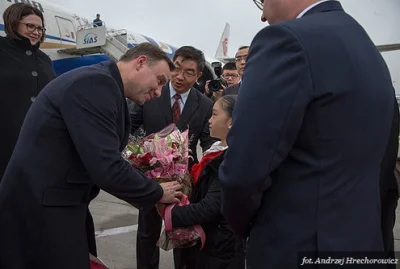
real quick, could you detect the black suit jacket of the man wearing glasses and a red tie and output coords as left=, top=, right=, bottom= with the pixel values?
left=128, top=83, right=217, bottom=167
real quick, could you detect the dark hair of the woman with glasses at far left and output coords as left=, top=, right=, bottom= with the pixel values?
left=3, top=3, right=46, bottom=43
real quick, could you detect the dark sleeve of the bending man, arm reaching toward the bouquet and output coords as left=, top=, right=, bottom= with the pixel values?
left=60, top=76, right=163, bottom=208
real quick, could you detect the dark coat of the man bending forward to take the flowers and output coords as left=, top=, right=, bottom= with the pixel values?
left=0, top=62, right=163, bottom=269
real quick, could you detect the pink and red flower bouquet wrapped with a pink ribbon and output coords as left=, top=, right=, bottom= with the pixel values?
left=122, top=124, right=205, bottom=250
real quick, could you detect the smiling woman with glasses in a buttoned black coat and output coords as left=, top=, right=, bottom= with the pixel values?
left=0, top=3, right=56, bottom=179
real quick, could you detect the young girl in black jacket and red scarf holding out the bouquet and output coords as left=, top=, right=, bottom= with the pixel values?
left=157, top=95, right=245, bottom=269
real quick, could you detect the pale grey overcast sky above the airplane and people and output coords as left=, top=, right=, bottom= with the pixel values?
left=49, top=0, right=400, bottom=57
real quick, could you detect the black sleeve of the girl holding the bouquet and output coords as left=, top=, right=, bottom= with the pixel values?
left=171, top=180, right=221, bottom=227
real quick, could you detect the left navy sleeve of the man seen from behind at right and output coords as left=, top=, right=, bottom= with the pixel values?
left=219, top=25, right=313, bottom=236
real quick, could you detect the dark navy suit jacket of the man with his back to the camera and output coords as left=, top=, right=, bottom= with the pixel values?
left=219, top=1, right=398, bottom=269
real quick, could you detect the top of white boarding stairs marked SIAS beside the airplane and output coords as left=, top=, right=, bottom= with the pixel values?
left=58, top=26, right=129, bottom=61
